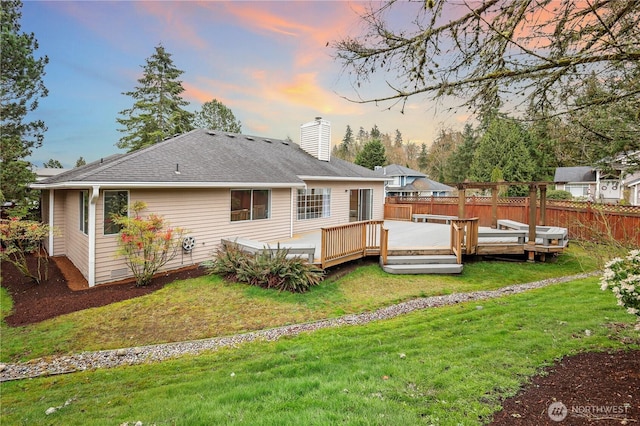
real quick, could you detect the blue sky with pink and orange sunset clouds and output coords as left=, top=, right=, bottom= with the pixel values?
left=21, top=0, right=466, bottom=167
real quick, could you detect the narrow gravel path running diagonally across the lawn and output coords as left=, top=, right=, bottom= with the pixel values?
left=0, top=272, right=600, bottom=382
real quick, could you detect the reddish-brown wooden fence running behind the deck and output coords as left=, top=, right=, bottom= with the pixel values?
left=385, top=196, right=640, bottom=247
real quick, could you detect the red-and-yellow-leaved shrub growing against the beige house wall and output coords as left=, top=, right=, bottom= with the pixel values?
left=113, top=201, right=184, bottom=287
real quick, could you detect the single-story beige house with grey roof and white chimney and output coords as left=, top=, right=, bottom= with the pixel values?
left=33, top=119, right=385, bottom=286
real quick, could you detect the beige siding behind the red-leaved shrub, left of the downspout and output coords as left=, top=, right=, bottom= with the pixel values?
left=96, top=189, right=291, bottom=284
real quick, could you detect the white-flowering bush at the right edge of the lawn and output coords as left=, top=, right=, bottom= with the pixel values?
left=600, top=250, right=640, bottom=331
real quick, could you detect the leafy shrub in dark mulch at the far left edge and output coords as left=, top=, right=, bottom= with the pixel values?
left=0, top=217, right=50, bottom=284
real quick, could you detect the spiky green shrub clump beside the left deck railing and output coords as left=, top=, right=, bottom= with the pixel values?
left=203, top=243, right=324, bottom=293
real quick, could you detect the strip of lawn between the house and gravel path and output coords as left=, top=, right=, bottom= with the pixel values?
left=0, top=247, right=596, bottom=362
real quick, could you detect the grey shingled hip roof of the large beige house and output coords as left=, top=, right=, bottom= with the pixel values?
left=33, top=129, right=384, bottom=188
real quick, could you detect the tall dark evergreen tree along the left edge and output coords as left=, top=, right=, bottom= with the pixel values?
left=0, top=0, right=49, bottom=205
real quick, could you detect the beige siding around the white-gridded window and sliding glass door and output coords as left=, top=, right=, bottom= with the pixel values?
left=291, top=181, right=384, bottom=234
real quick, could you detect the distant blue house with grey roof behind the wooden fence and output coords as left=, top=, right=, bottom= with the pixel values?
left=375, top=164, right=454, bottom=197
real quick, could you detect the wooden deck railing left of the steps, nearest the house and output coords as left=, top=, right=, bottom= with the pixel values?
left=320, top=220, right=388, bottom=269
